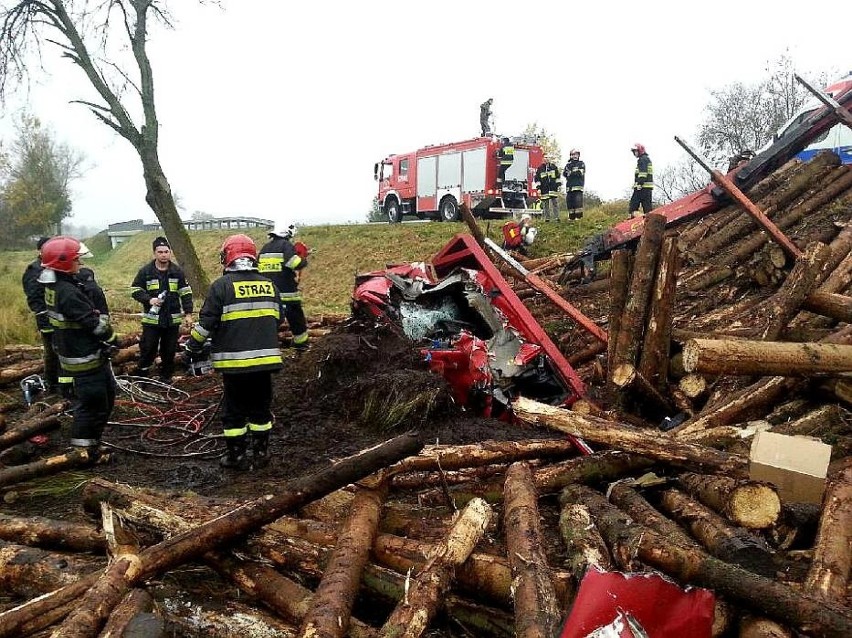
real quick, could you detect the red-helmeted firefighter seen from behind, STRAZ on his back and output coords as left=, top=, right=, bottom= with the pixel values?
left=186, top=235, right=283, bottom=470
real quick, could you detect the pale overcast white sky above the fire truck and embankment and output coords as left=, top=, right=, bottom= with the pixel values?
left=0, top=0, right=852, bottom=227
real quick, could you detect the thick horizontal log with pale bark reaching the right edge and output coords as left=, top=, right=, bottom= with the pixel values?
left=683, top=339, right=852, bottom=377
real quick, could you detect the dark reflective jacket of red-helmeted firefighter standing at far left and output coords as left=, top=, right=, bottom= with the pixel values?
left=44, top=272, right=113, bottom=376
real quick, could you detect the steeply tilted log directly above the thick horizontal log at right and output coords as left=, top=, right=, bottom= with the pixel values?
left=760, top=242, right=831, bottom=341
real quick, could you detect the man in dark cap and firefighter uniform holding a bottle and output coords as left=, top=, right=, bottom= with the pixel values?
left=130, top=237, right=192, bottom=383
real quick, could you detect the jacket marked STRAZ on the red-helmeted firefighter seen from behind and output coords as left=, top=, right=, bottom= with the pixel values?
left=190, top=270, right=284, bottom=374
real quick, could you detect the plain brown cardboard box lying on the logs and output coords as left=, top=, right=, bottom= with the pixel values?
left=749, top=431, right=831, bottom=504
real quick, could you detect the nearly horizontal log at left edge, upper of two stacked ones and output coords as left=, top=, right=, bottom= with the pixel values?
left=0, top=514, right=106, bottom=553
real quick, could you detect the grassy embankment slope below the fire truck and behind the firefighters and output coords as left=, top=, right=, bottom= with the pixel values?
left=0, top=202, right=626, bottom=347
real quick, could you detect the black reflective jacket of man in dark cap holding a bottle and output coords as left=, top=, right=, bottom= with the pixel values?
left=130, top=260, right=192, bottom=327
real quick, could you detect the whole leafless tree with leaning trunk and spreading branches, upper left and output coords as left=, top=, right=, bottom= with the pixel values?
left=0, top=0, right=209, bottom=296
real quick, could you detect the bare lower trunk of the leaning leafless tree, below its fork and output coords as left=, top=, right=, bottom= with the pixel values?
left=141, top=148, right=210, bottom=299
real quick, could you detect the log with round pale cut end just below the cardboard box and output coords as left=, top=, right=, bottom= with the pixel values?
left=677, top=472, right=781, bottom=529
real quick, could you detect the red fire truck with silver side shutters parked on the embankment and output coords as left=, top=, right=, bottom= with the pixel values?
left=373, top=135, right=544, bottom=223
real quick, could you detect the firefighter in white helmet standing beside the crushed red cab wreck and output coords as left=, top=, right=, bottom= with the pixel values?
left=258, top=222, right=308, bottom=350
